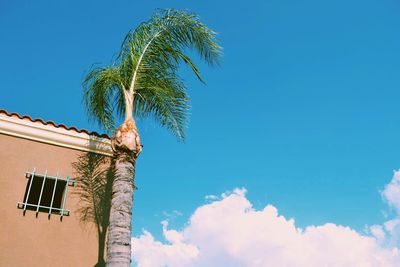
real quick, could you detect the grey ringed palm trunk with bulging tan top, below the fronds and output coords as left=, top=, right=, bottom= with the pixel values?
left=107, top=118, right=142, bottom=267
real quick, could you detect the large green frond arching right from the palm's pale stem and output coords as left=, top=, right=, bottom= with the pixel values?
left=126, top=10, right=221, bottom=139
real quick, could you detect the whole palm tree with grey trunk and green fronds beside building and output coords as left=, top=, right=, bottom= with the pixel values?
left=83, top=9, right=221, bottom=266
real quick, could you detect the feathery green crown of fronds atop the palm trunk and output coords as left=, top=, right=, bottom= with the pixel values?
left=83, top=9, right=221, bottom=140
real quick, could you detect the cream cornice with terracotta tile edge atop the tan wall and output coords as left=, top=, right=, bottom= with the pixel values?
left=0, top=113, right=113, bottom=156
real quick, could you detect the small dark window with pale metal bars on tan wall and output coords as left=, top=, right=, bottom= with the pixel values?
left=17, top=169, right=76, bottom=219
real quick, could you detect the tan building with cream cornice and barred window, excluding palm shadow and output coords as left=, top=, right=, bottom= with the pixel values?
left=0, top=110, right=111, bottom=267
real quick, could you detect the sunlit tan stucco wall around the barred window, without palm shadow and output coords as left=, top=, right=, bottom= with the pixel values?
left=0, top=134, right=97, bottom=267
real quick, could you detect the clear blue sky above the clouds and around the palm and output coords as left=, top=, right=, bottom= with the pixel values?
left=0, top=0, right=400, bottom=252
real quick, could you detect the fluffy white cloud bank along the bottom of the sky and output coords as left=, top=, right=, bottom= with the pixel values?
left=132, top=175, right=400, bottom=267
